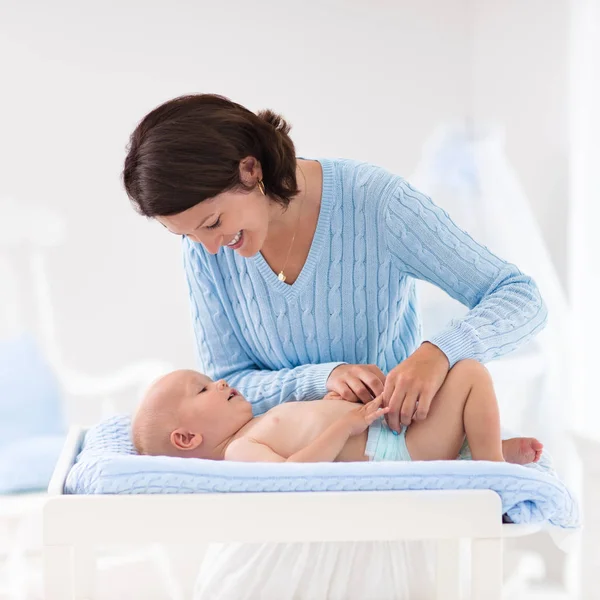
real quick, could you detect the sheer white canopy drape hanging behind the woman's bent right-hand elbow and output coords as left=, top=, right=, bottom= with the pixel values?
left=411, top=123, right=570, bottom=474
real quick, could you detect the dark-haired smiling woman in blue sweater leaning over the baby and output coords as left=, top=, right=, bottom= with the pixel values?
left=123, top=94, right=546, bottom=431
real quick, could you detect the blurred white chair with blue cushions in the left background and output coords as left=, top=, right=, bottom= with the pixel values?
left=0, top=197, right=178, bottom=600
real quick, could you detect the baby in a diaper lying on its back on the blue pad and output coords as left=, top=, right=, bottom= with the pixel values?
left=132, top=360, right=542, bottom=464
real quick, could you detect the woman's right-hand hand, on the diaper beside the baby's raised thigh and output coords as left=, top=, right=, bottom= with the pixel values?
left=383, top=342, right=450, bottom=432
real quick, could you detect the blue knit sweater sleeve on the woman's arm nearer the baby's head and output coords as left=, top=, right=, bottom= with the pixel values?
left=183, top=240, right=344, bottom=415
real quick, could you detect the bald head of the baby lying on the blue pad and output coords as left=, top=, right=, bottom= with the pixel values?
left=132, top=371, right=252, bottom=459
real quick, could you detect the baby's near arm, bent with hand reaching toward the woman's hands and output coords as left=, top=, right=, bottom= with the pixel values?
left=225, top=396, right=388, bottom=462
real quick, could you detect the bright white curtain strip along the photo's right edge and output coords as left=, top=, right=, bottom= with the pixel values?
left=569, top=0, right=600, bottom=428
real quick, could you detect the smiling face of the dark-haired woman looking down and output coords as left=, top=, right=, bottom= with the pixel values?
left=156, top=188, right=273, bottom=258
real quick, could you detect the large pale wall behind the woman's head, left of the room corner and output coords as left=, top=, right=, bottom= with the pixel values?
left=0, top=0, right=471, bottom=384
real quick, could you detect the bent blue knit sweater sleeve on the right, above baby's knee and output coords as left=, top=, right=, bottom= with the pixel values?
left=384, top=178, right=547, bottom=367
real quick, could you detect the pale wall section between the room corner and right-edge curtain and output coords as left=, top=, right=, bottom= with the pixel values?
left=472, top=0, right=569, bottom=285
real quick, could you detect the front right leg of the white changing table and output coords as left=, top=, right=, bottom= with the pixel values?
left=471, top=538, right=503, bottom=600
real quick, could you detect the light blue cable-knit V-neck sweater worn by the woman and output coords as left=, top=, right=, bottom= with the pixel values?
left=183, top=159, right=547, bottom=414
